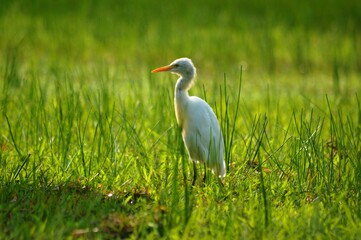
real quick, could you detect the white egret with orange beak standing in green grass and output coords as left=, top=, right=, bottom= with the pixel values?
left=152, top=58, right=226, bottom=185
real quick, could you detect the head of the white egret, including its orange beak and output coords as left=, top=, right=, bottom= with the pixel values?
left=152, top=58, right=196, bottom=78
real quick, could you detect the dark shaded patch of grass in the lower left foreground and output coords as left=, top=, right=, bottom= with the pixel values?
left=0, top=181, right=166, bottom=239
